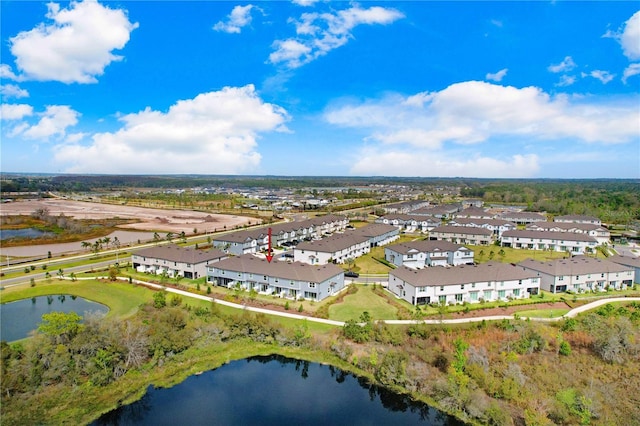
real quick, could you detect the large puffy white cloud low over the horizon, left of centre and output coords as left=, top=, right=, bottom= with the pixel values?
left=55, top=85, right=288, bottom=174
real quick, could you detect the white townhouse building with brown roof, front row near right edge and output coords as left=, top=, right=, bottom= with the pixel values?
left=518, top=256, right=635, bottom=293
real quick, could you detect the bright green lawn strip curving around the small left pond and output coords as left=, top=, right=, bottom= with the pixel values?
left=0, top=278, right=153, bottom=317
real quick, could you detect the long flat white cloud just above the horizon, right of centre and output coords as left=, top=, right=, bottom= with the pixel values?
left=350, top=148, right=540, bottom=178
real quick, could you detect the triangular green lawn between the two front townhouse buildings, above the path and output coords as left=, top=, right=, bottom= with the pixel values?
left=329, top=285, right=398, bottom=321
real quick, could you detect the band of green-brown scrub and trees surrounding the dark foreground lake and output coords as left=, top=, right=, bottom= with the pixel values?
left=0, top=286, right=640, bottom=425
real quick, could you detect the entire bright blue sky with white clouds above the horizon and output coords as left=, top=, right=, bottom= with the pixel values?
left=0, top=0, right=640, bottom=178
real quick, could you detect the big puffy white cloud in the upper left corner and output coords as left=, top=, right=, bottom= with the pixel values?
left=9, top=0, right=138, bottom=83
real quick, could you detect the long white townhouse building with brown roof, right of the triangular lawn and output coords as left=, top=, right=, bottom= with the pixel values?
left=388, top=262, right=540, bottom=305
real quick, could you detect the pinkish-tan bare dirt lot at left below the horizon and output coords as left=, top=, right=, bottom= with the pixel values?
left=0, top=199, right=256, bottom=235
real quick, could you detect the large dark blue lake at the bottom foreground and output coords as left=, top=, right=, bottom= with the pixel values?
left=93, top=356, right=464, bottom=426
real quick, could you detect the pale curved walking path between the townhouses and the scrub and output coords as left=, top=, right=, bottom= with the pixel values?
left=82, top=277, right=640, bottom=327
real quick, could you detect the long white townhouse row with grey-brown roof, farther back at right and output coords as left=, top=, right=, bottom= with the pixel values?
left=500, top=230, right=598, bottom=255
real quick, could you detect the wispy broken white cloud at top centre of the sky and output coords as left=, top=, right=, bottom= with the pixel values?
left=269, top=5, right=404, bottom=69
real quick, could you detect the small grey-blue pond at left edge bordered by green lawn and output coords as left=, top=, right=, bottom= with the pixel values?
left=0, top=294, right=109, bottom=342
